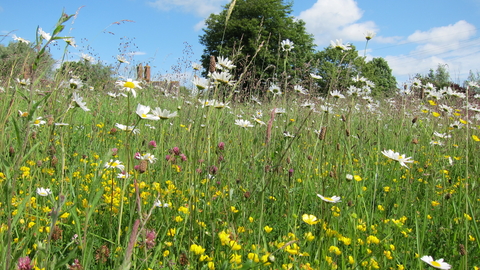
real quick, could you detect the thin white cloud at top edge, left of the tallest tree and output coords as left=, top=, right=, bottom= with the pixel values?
left=148, top=0, right=229, bottom=18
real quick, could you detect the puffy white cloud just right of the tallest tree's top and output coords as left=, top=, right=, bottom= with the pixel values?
left=298, top=0, right=378, bottom=46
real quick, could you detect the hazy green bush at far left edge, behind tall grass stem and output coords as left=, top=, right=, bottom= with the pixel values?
left=0, top=42, right=54, bottom=79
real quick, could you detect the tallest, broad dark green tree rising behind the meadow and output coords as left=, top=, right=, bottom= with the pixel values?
left=200, top=0, right=315, bottom=94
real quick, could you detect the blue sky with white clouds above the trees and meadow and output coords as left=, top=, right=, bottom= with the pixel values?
left=0, top=0, right=480, bottom=84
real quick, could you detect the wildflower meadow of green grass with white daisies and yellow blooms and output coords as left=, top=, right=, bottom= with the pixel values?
left=0, top=9, right=480, bottom=270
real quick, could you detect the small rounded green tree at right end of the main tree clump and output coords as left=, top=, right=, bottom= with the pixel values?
left=362, top=57, right=397, bottom=95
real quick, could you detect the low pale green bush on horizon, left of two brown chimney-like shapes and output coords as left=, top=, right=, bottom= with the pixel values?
left=57, top=60, right=114, bottom=89
